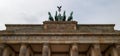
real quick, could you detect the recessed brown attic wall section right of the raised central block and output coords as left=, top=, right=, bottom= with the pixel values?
left=77, top=24, right=115, bottom=32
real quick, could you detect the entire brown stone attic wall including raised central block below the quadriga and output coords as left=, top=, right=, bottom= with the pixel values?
left=6, top=21, right=115, bottom=33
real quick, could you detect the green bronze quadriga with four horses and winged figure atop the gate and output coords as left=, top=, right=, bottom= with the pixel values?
left=48, top=6, right=73, bottom=21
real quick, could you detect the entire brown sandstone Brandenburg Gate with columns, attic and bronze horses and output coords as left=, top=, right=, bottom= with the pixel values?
left=0, top=6, right=120, bottom=56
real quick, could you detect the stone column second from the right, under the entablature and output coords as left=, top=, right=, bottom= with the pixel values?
left=91, top=44, right=102, bottom=56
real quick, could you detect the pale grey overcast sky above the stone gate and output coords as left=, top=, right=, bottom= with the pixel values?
left=0, top=0, right=120, bottom=30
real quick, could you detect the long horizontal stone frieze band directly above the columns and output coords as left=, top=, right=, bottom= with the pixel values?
left=0, top=36, right=120, bottom=43
